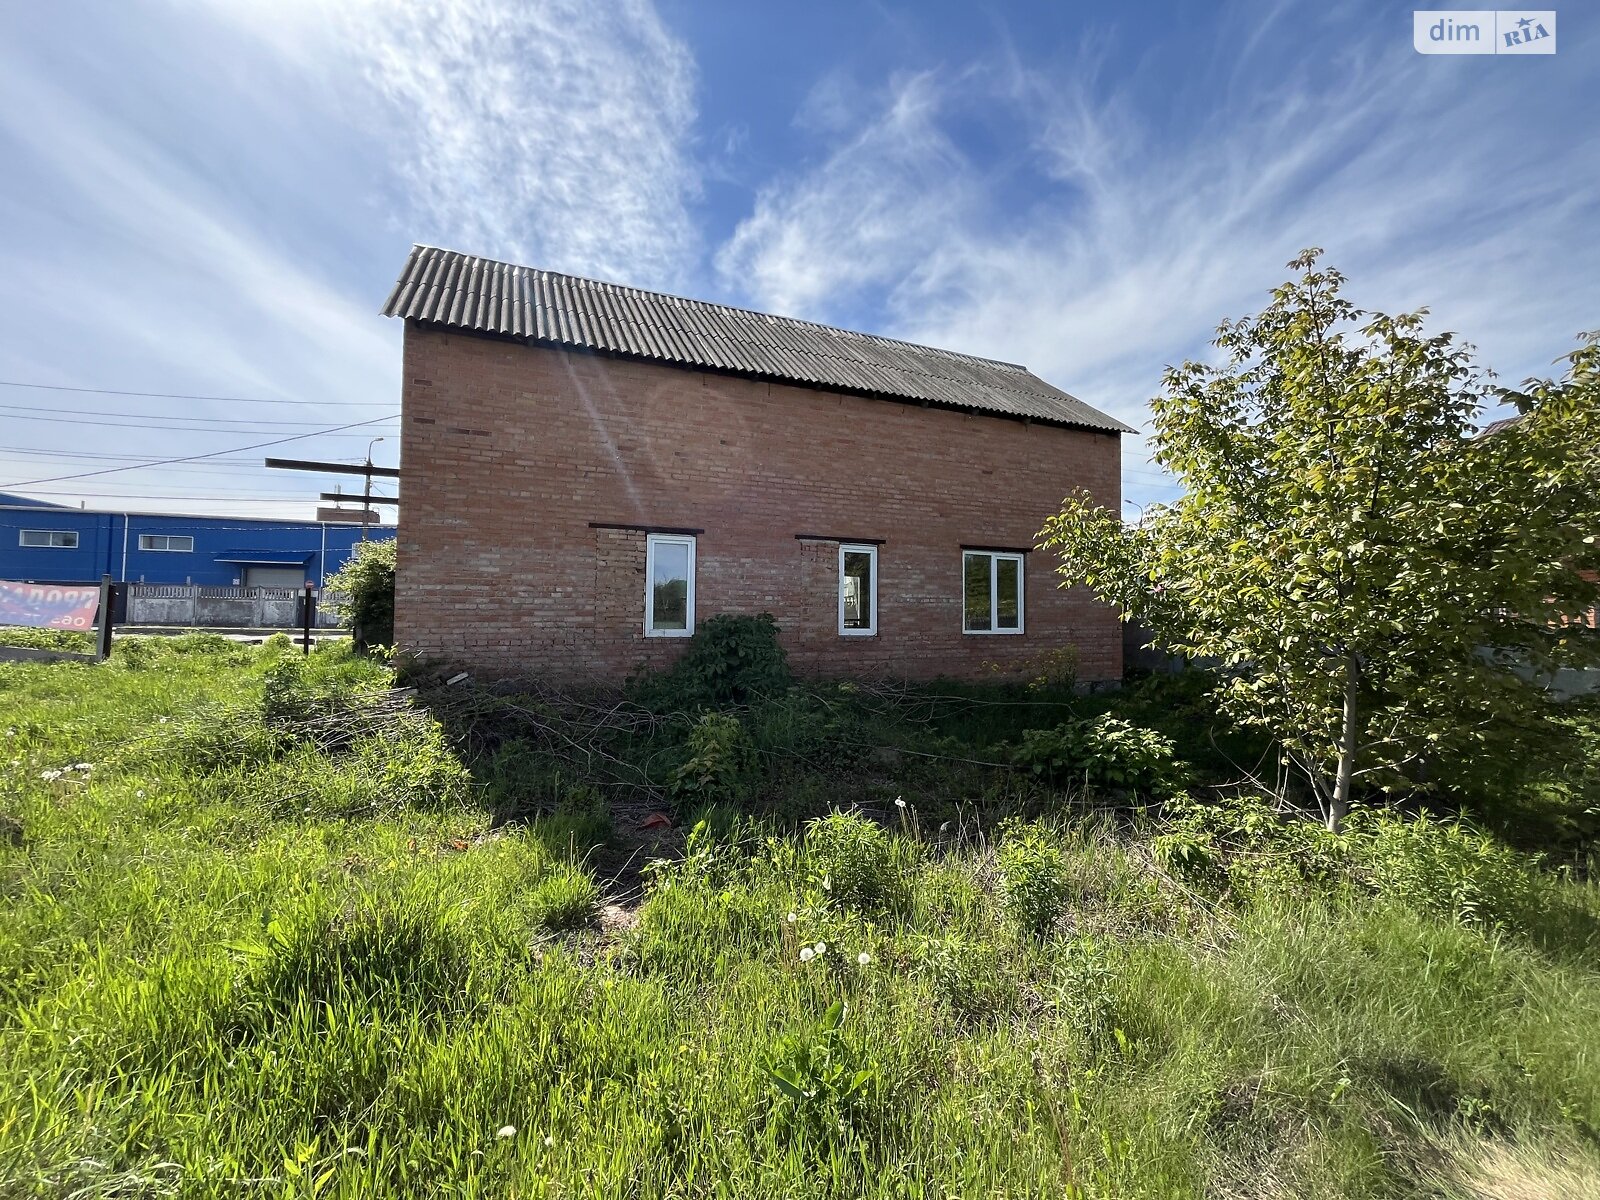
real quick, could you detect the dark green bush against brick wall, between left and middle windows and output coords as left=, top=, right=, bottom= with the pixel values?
left=629, top=613, right=794, bottom=712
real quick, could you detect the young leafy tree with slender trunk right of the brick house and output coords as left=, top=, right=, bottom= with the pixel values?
left=1040, top=250, right=1600, bottom=830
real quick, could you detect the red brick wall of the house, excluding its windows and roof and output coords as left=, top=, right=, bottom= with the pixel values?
left=395, top=326, right=1122, bottom=682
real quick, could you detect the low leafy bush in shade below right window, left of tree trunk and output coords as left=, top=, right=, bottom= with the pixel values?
left=1011, top=714, right=1186, bottom=795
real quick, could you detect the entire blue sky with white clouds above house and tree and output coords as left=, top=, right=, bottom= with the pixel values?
left=0, top=0, right=1600, bottom=515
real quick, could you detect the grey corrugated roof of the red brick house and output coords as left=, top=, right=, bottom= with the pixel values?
left=384, top=246, right=1133, bottom=434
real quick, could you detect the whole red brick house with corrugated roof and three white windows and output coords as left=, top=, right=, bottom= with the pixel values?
left=384, top=246, right=1130, bottom=683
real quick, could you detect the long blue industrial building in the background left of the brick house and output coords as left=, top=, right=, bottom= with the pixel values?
left=0, top=493, right=395, bottom=587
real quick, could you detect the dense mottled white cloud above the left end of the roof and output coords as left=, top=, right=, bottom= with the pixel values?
left=230, top=0, right=699, bottom=286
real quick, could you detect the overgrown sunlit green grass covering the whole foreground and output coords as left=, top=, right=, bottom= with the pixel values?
left=0, top=649, right=1600, bottom=1198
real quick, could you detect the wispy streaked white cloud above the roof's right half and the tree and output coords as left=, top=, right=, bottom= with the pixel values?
left=718, top=27, right=1600, bottom=501
